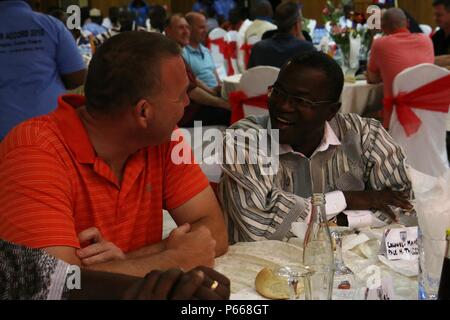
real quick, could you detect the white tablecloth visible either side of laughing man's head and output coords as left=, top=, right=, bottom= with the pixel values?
left=222, top=74, right=383, bottom=115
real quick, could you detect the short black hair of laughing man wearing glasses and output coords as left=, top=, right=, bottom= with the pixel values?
left=280, top=51, right=344, bottom=101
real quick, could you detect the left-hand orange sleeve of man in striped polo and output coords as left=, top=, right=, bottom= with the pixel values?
left=0, top=147, right=80, bottom=248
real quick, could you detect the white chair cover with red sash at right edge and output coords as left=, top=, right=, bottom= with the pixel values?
left=389, top=63, right=450, bottom=177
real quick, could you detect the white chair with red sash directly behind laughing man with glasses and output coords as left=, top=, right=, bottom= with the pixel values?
left=230, top=66, right=280, bottom=122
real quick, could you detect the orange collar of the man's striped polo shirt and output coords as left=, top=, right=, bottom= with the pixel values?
left=52, top=94, right=96, bottom=164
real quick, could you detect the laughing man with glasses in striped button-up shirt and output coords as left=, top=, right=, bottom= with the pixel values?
left=219, top=51, right=412, bottom=243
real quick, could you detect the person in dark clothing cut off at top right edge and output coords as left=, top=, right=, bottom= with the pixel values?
left=432, top=0, right=450, bottom=67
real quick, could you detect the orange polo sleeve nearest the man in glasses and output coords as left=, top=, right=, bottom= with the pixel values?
left=163, top=129, right=209, bottom=210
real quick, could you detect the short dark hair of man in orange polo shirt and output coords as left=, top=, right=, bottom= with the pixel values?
left=85, top=31, right=181, bottom=115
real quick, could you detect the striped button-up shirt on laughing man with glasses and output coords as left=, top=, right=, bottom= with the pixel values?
left=219, top=114, right=411, bottom=242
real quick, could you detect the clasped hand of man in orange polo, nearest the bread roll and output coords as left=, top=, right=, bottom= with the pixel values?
left=166, top=224, right=216, bottom=270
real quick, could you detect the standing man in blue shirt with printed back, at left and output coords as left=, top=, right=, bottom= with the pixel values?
left=0, top=0, right=86, bottom=140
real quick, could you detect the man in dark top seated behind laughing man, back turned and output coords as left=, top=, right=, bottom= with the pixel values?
left=248, top=2, right=316, bottom=68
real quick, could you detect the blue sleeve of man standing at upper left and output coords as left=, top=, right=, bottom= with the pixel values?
left=56, top=21, right=86, bottom=74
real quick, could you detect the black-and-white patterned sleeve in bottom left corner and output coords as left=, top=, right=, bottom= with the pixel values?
left=0, top=239, right=69, bottom=300
